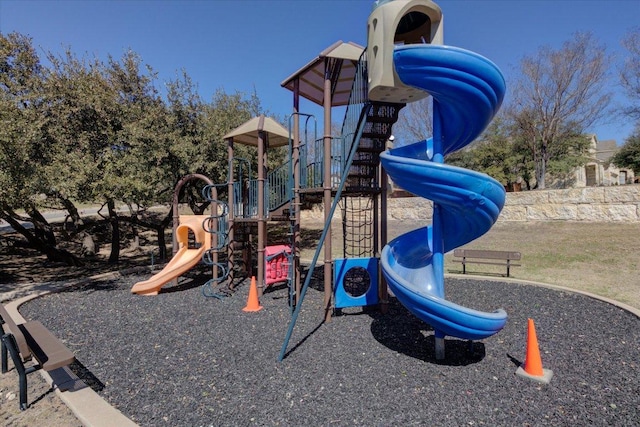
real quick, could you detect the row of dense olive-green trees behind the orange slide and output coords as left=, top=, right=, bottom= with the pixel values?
left=0, top=34, right=272, bottom=264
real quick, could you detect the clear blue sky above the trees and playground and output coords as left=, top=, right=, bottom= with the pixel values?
left=0, top=0, right=640, bottom=144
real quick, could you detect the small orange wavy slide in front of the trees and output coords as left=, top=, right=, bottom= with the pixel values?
left=131, top=215, right=211, bottom=295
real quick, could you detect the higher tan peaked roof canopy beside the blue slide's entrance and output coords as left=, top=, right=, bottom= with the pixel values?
left=280, top=40, right=364, bottom=107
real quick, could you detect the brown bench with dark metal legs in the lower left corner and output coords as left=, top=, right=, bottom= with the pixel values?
left=0, top=304, right=75, bottom=411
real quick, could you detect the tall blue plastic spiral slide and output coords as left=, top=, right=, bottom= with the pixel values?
left=380, top=45, right=507, bottom=340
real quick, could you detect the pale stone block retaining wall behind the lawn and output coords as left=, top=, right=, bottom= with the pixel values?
left=303, top=185, right=640, bottom=222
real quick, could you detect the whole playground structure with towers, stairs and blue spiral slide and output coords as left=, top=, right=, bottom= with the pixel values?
left=134, top=0, right=507, bottom=360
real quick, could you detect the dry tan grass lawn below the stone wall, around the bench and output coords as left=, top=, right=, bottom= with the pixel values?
left=302, top=221, right=640, bottom=308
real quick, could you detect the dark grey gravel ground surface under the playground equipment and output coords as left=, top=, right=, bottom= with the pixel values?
left=11, top=269, right=640, bottom=426
